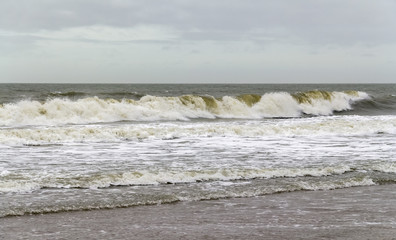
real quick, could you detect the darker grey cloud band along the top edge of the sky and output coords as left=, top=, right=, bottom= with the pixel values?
left=0, top=0, right=396, bottom=44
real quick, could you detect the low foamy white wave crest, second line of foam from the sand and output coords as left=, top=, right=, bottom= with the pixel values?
left=0, top=165, right=362, bottom=192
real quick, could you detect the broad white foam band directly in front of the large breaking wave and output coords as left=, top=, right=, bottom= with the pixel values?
left=0, top=116, right=396, bottom=145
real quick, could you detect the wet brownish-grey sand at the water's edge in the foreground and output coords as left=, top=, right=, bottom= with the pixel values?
left=0, top=185, right=396, bottom=240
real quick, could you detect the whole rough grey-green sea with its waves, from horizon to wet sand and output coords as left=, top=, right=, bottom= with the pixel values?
left=0, top=84, right=396, bottom=217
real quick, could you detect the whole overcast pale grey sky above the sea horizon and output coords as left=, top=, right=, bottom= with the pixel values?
left=0, top=0, right=396, bottom=83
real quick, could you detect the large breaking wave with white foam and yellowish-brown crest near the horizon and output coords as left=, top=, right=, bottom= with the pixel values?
left=0, top=90, right=370, bottom=127
